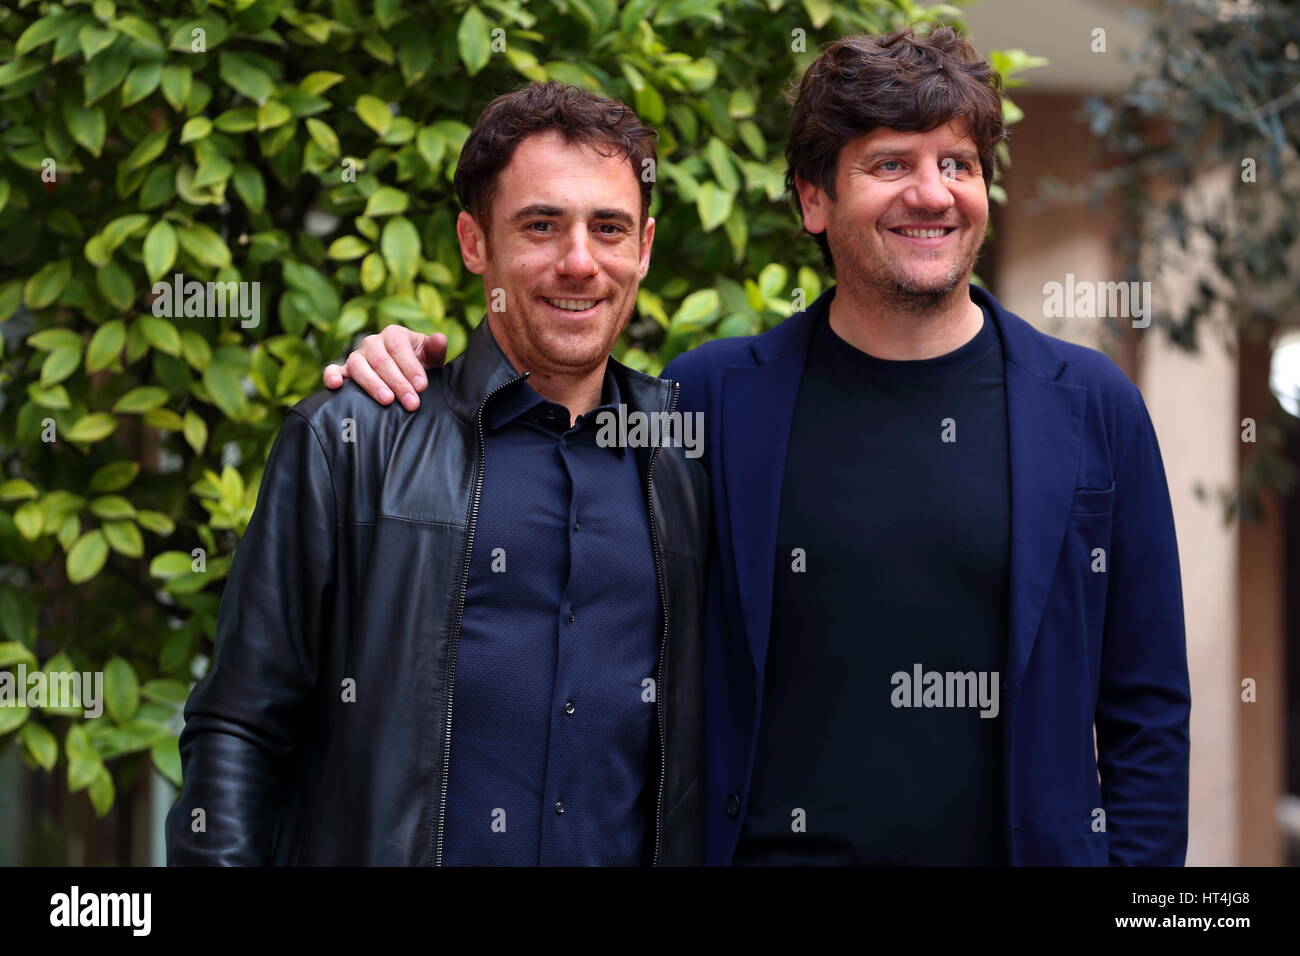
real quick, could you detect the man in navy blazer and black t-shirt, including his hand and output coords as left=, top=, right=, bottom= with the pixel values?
left=326, top=29, right=1191, bottom=866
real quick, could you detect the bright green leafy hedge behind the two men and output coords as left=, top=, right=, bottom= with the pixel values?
left=0, top=0, right=1035, bottom=816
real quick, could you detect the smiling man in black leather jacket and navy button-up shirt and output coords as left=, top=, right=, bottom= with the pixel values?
left=166, top=85, right=710, bottom=865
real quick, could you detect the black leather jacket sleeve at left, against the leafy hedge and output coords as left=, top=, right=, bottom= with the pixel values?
left=166, top=411, right=337, bottom=866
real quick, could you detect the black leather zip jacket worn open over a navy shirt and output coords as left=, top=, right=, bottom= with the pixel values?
left=166, top=321, right=710, bottom=866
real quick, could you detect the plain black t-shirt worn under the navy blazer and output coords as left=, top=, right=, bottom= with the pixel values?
left=736, top=300, right=1010, bottom=866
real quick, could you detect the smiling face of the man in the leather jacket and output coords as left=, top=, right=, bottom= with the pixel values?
left=456, top=131, right=654, bottom=378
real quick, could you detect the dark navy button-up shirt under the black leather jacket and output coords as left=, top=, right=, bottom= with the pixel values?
left=443, top=368, right=660, bottom=866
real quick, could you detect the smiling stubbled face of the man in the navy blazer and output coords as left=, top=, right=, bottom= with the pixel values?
left=798, top=122, right=988, bottom=310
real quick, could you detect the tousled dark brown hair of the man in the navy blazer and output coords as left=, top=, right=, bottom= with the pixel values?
left=785, top=26, right=1006, bottom=271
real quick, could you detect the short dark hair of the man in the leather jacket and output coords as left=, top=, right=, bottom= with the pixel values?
left=452, top=81, right=659, bottom=233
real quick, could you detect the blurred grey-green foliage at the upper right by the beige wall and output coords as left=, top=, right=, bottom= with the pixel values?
left=1076, top=0, right=1300, bottom=522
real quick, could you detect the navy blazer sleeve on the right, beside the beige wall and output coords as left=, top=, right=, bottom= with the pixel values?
left=1096, top=390, right=1191, bottom=866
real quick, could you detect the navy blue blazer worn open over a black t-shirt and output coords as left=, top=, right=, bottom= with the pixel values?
left=663, top=286, right=1191, bottom=866
